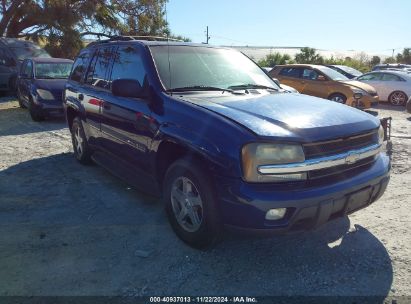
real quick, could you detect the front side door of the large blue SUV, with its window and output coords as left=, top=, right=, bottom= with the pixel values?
left=101, top=44, right=155, bottom=173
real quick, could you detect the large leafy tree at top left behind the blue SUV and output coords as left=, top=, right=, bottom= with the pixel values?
left=0, top=0, right=185, bottom=58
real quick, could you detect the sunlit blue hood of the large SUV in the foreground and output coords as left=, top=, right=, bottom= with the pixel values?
left=180, top=92, right=379, bottom=142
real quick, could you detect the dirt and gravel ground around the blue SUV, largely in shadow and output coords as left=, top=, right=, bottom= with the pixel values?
left=0, top=97, right=411, bottom=303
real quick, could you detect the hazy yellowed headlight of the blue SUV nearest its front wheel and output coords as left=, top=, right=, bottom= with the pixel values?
left=241, top=143, right=307, bottom=182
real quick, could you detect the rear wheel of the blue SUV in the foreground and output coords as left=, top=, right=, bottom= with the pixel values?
left=71, top=117, right=92, bottom=165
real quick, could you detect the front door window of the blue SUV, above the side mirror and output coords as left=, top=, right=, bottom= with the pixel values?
left=110, top=46, right=147, bottom=86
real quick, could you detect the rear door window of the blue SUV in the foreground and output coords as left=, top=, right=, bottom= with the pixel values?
left=86, top=47, right=113, bottom=89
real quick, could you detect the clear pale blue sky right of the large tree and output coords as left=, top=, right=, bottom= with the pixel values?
left=167, top=0, right=411, bottom=55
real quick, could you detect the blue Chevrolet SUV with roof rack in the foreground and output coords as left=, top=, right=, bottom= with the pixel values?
left=64, top=37, right=390, bottom=248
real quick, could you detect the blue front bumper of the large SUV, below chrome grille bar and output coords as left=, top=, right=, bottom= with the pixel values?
left=216, top=153, right=390, bottom=233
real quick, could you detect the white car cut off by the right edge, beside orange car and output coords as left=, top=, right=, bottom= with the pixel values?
left=356, top=70, right=411, bottom=106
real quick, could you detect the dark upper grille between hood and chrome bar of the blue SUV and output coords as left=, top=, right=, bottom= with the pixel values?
left=303, top=131, right=378, bottom=159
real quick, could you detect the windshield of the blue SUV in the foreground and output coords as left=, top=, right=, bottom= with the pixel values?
left=150, top=46, right=279, bottom=90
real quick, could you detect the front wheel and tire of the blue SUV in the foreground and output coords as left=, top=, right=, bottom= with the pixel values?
left=163, top=159, right=220, bottom=249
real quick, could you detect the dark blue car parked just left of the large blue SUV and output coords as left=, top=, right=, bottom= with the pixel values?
left=17, top=58, right=73, bottom=121
